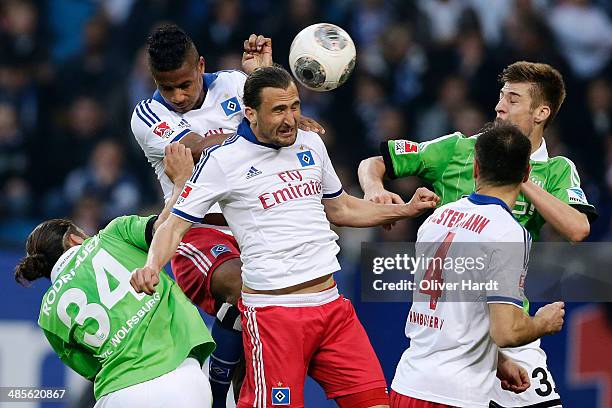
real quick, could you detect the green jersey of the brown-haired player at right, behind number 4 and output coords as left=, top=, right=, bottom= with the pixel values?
left=381, top=132, right=597, bottom=241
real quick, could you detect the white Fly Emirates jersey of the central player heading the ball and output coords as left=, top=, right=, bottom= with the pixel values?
left=172, top=119, right=342, bottom=290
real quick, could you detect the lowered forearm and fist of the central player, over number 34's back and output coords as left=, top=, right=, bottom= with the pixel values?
left=130, top=216, right=192, bottom=295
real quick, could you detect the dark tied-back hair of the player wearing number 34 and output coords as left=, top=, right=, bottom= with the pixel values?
left=15, top=219, right=82, bottom=286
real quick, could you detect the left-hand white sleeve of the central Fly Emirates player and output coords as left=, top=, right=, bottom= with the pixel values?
left=172, top=146, right=229, bottom=223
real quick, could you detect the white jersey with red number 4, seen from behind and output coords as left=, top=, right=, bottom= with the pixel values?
left=391, top=193, right=531, bottom=407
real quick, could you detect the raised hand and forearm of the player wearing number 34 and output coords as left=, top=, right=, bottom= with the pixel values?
left=153, top=142, right=193, bottom=232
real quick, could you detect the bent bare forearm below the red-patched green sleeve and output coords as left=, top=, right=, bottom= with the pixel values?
left=357, top=156, right=404, bottom=204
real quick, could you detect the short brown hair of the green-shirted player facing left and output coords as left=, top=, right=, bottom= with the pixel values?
left=499, top=61, right=565, bottom=129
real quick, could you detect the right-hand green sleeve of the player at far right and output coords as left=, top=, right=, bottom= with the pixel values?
left=546, top=156, right=598, bottom=222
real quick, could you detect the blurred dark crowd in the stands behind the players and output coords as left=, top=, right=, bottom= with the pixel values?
left=0, top=0, right=612, bottom=248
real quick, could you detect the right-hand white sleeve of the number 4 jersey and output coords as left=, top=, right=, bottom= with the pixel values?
left=486, top=227, right=531, bottom=308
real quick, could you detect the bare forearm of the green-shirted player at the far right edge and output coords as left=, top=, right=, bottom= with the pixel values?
left=521, top=181, right=591, bottom=242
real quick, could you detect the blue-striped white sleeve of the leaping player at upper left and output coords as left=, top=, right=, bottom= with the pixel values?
left=131, top=99, right=191, bottom=164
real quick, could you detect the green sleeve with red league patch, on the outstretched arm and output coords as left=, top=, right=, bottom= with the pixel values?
left=380, top=132, right=463, bottom=183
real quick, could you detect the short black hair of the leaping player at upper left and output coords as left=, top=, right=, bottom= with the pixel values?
left=147, top=24, right=198, bottom=72
